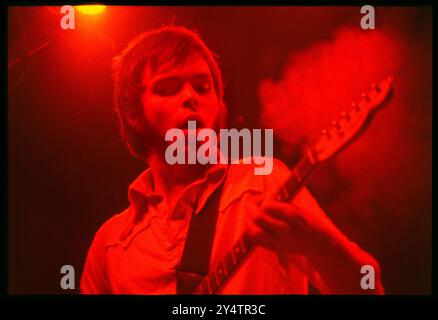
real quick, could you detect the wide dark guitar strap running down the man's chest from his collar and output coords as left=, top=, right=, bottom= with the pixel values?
left=176, top=181, right=224, bottom=294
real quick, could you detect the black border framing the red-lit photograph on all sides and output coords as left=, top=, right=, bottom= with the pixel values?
left=0, top=0, right=438, bottom=319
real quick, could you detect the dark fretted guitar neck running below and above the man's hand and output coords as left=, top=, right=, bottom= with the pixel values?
left=194, top=150, right=316, bottom=294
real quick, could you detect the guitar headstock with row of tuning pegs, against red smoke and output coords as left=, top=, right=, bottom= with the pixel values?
left=313, top=76, right=394, bottom=162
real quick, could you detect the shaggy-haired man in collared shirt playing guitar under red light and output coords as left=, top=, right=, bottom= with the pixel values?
left=81, top=26, right=383, bottom=294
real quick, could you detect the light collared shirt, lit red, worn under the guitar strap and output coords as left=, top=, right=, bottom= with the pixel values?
left=81, top=159, right=326, bottom=294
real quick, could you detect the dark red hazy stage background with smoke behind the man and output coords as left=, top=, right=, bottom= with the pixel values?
left=8, top=7, right=432, bottom=294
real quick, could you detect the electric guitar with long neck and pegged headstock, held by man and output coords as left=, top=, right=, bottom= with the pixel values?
left=193, top=76, right=393, bottom=294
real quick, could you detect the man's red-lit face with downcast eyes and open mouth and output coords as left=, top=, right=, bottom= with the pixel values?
left=142, top=56, right=223, bottom=143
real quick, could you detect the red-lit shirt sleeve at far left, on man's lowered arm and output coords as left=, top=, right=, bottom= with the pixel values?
left=80, top=225, right=111, bottom=294
